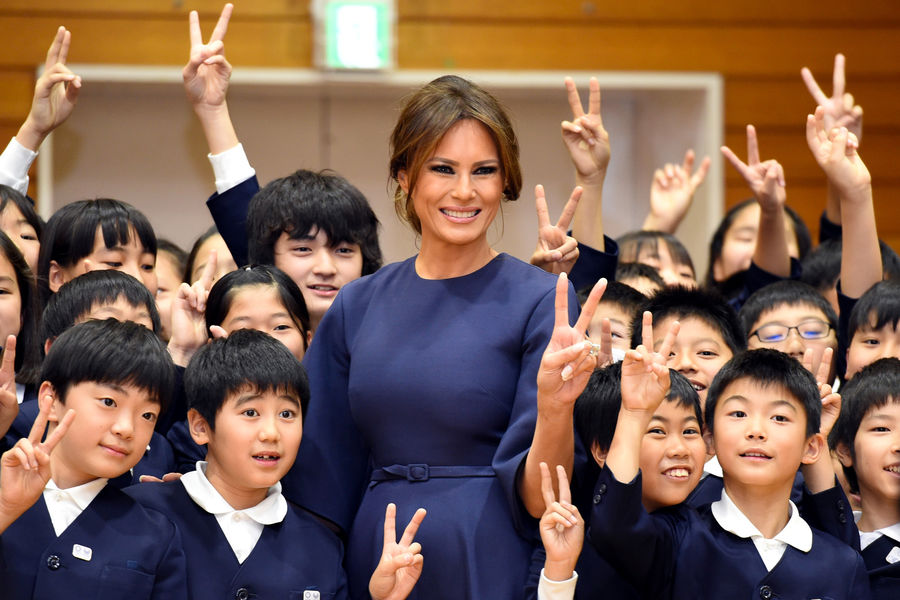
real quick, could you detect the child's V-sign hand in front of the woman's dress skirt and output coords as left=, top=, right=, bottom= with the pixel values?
left=369, top=504, right=425, bottom=600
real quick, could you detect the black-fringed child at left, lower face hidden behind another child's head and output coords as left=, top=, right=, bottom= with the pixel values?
left=37, top=198, right=156, bottom=303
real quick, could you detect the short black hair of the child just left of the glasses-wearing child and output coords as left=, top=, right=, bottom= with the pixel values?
left=631, top=286, right=747, bottom=354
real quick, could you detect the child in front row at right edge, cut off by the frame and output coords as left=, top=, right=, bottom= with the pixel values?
left=828, top=358, right=900, bottom=600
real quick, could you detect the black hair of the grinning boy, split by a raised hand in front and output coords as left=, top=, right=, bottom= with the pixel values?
left=575, top=363, right=703, bottom=452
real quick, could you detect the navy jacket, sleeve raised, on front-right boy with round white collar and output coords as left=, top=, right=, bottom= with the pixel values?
left=589, top=468, right=870, bottom=600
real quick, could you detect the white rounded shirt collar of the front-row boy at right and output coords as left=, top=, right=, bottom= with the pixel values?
left=710, top=490, right=812, bottom=571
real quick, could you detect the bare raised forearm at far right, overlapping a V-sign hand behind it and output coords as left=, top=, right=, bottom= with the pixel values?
left=806, top=106, right=882, bottom=298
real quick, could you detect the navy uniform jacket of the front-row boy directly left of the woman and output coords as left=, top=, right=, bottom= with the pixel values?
left=127, top=481, right=347, bottom=600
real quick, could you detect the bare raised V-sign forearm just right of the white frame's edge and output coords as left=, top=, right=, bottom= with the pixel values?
left=722, top=125, right=791, bottom=278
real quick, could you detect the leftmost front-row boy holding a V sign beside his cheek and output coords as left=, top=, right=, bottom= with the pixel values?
left=0, top=319, right=187, bottom=600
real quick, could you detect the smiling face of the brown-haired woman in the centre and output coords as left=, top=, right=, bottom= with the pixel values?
left=399, top=119, right=503, bottom=248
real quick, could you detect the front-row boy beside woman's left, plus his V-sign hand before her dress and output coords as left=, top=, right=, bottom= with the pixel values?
left=128, top=329, right=424, bottom=600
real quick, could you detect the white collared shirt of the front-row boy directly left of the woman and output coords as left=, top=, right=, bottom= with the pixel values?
left=179, top=461, right=287, bottom=563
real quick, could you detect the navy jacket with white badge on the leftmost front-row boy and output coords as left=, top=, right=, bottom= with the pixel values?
left=0, top=485, right=187, bottom=600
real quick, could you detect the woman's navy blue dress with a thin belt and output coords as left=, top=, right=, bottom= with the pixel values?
left=282, top=254, right=578, bottom=600
